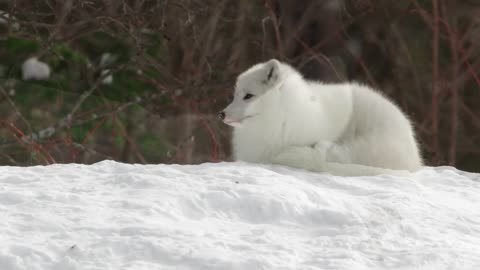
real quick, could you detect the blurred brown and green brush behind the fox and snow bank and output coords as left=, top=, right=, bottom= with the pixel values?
left=0, top=0, right=480, bottom=172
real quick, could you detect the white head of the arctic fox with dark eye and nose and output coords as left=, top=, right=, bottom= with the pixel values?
left=219, top=59, right=282, bottom=126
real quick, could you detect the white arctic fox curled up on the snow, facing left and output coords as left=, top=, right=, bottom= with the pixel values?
left=219, top=59, right=422, bottom=176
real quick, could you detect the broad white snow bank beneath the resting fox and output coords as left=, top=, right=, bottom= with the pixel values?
left=0, top=161, right=480, bottom=270
